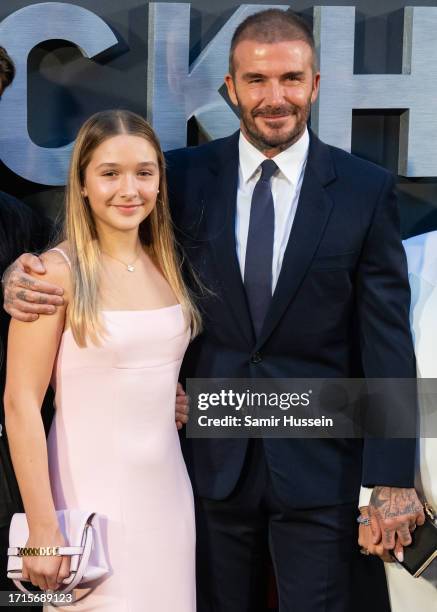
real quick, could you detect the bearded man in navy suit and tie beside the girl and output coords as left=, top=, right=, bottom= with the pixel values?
left=6, top=10, right=423, bottom=612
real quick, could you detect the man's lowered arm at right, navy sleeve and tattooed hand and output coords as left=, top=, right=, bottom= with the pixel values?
left=357, top=175, right=424, bottom=558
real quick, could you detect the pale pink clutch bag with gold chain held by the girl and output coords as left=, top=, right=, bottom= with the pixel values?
left=8, top=510, right=109, bottom=593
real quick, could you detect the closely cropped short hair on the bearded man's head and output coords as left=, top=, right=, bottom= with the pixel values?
left=229, top=9, right=317, bottom=76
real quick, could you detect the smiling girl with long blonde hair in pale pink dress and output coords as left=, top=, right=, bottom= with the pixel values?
left=5, top=111, right=200, bottom=612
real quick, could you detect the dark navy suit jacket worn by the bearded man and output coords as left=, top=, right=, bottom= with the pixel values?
left=166, top=133, right=416, bottom=508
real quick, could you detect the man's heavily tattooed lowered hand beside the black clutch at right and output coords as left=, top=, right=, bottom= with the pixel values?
left=369, top=487, right=425, bottom=561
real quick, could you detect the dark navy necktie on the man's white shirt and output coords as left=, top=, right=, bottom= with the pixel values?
left=244, top=159, right=278, bottom=337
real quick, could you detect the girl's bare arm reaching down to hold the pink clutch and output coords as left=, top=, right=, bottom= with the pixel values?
left=4, top=252, right=70, bottom=590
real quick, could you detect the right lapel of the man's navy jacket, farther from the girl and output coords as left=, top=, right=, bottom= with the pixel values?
left=257, top=134, right=335, bottom=348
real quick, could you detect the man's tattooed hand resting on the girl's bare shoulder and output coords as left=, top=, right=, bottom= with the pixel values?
left=2, top=253, right=64, bottom=322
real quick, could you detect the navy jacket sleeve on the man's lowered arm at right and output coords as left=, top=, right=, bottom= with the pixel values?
left=357, top=175, right=417, bottom=487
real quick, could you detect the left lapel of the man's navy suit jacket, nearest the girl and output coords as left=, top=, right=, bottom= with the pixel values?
left=205, top=132, right=254, bottom=345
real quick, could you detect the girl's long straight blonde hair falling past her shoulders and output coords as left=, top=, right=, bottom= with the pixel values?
left=64, top=110, right=201, bottom=347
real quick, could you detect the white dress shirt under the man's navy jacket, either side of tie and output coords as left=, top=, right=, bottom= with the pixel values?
left=235, top=129, right=310, bottom=292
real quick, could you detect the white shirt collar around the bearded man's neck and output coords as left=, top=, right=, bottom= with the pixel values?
left=238, top=128, right=310, bottom=186
